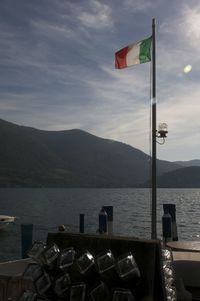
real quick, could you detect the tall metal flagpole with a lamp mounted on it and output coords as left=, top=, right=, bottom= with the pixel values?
left=151, top=19, right=157, bottom=239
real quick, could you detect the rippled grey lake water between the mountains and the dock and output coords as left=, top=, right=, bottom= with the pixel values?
left=0, top=188, right=200, bottom=262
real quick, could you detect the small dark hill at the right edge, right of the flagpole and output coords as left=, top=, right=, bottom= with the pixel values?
left=158, top=166, right=200, bottom=188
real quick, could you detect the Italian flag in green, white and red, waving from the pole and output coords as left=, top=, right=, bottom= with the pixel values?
left=115, top=37, right=152, bottom=69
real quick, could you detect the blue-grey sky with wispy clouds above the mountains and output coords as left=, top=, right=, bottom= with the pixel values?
left=0, top=0, right=200, bottom=161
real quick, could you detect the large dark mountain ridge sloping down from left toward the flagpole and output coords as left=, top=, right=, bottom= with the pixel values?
left=0, top=119, right=180, bottom=187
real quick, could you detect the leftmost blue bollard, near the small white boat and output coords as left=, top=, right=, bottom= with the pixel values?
left=21, top=224, right=33, bottom=259
